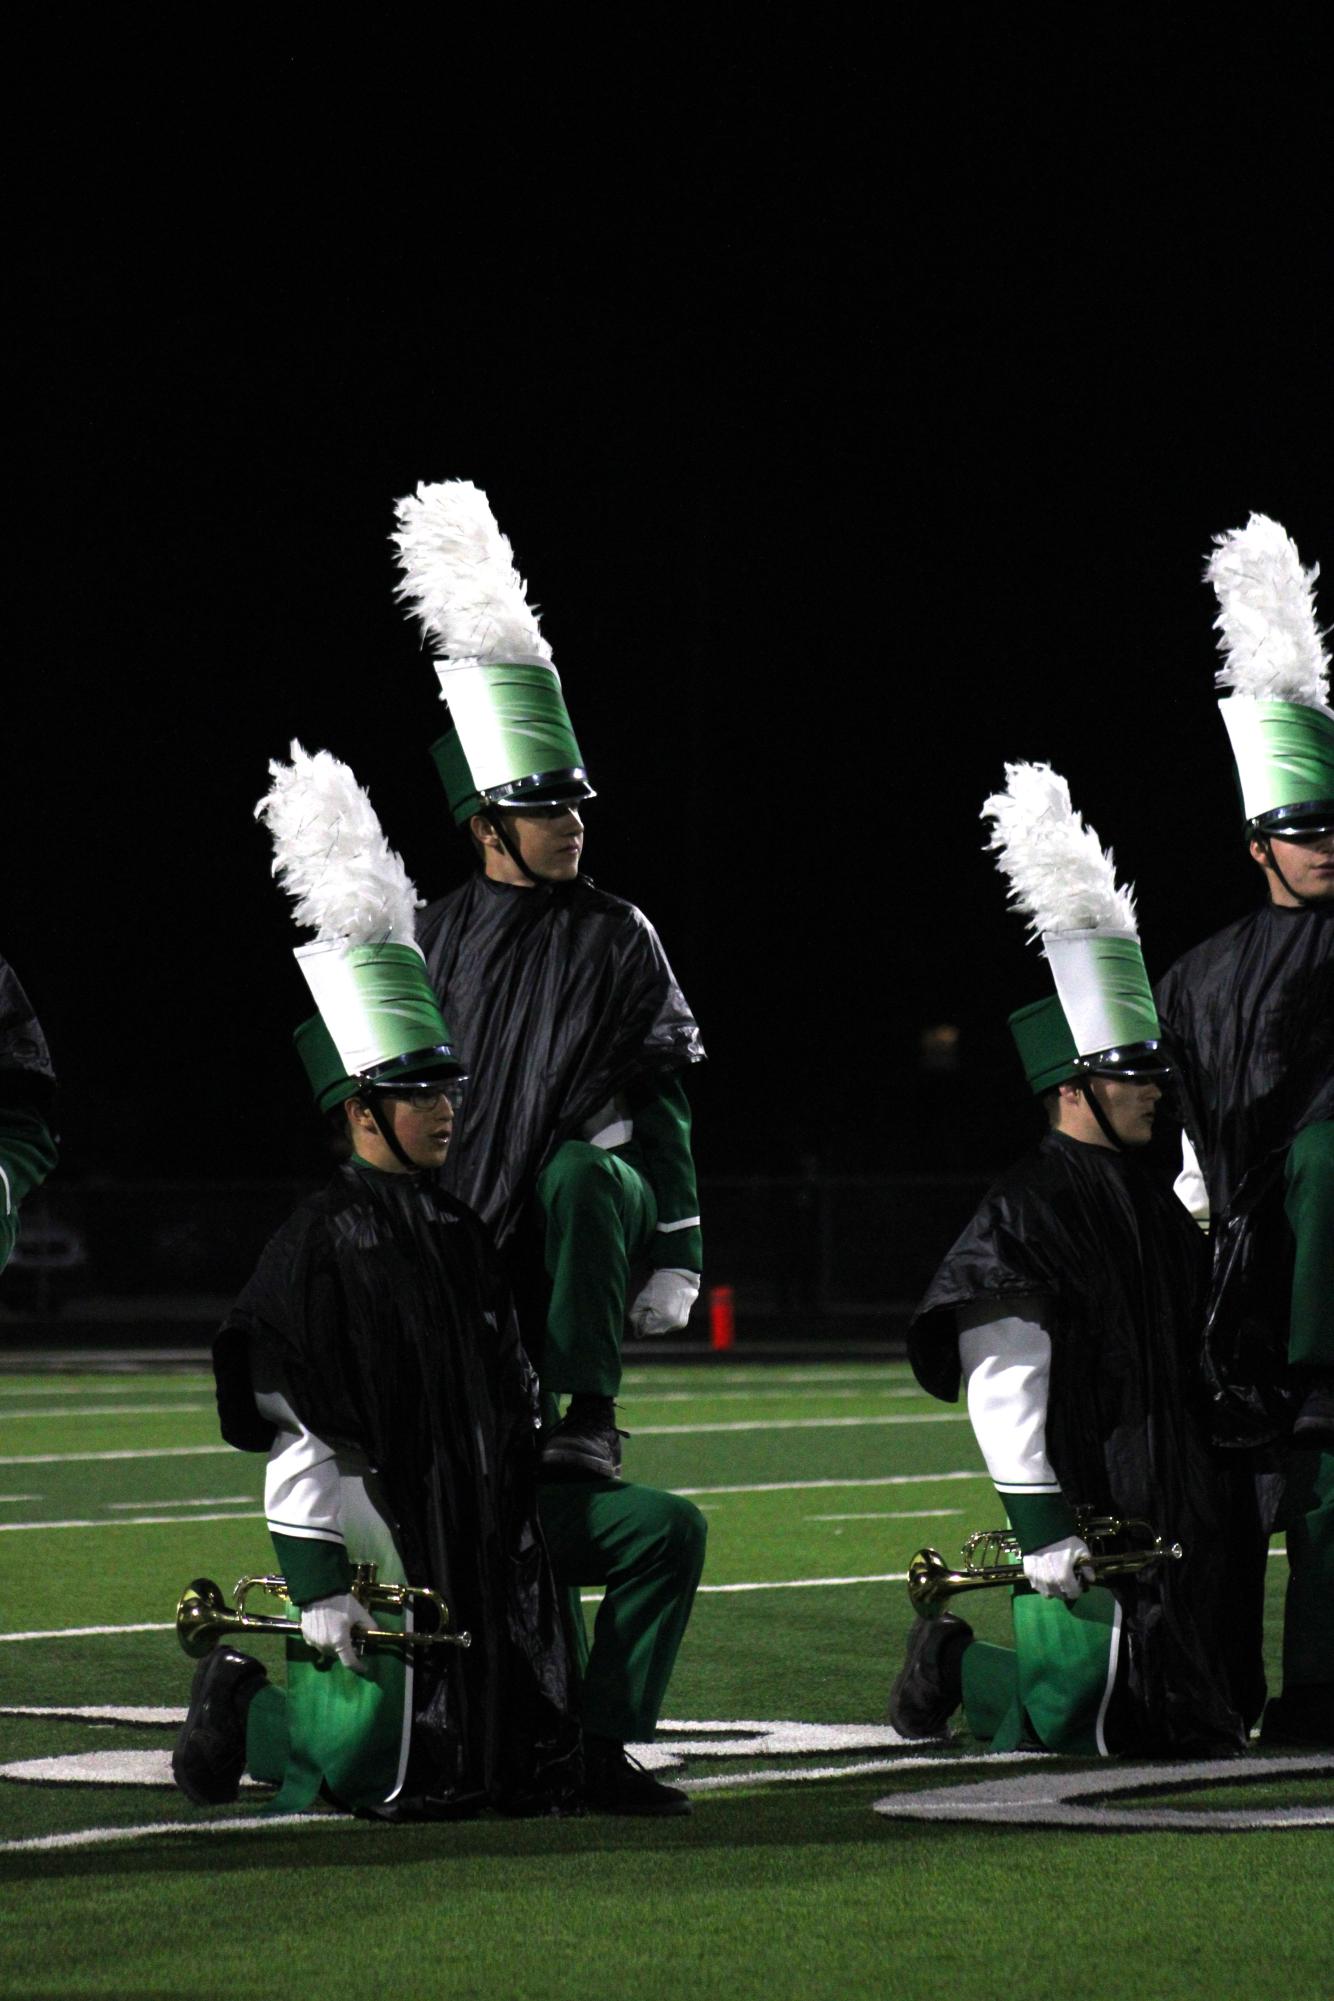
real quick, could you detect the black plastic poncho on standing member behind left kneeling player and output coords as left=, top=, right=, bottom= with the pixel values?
left=418, top=872, right=704, bottom=1247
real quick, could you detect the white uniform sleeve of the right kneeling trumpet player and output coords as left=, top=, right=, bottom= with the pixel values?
left=958, top=1295, right=1060, bottom=1495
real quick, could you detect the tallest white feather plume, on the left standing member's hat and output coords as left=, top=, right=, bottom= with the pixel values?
left=390, top=480, right=552, bottom=666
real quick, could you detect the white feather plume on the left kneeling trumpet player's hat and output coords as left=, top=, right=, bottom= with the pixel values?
left=254, top=742, right=424, bottom=944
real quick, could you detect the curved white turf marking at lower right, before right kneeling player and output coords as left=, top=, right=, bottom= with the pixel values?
left=872, top=1751, right=1334, bottom=1835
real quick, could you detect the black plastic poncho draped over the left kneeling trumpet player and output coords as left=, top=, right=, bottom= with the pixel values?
left=214, top=1165, right=578, bottom=1813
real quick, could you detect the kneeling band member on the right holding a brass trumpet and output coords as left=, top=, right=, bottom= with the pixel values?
left=890, top=764, right=1258, bottom=1755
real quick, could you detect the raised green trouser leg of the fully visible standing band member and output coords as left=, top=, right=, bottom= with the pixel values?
left=536, top=1139, right=658, bottom=1397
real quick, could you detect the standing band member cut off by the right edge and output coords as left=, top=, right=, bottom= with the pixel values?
left=1158, top=514, right=1334, bottom=1745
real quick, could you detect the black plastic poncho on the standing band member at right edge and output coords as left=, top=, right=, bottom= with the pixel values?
left=1154, top=904, right=1334, bottom=1445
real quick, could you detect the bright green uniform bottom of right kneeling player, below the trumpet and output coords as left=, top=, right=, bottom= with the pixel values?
left=964, top=1585, right=1120, bottom=1757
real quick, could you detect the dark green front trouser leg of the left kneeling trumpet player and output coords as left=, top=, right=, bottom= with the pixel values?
left=538, top=1481, right=708, bottom=1743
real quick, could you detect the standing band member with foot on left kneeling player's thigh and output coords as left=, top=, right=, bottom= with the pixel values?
left=394, top=480, right=704, bottom=1479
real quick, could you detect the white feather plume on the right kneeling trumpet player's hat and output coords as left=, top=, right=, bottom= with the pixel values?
left=982, top=764, right=1138, bottom=938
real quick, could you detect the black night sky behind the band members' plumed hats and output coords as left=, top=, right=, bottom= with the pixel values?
left=10, top=27, right=1334, bottom=1179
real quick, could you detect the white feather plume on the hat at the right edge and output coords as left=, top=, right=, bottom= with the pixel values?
left=1204, top=514, right=1330, bottom=714
